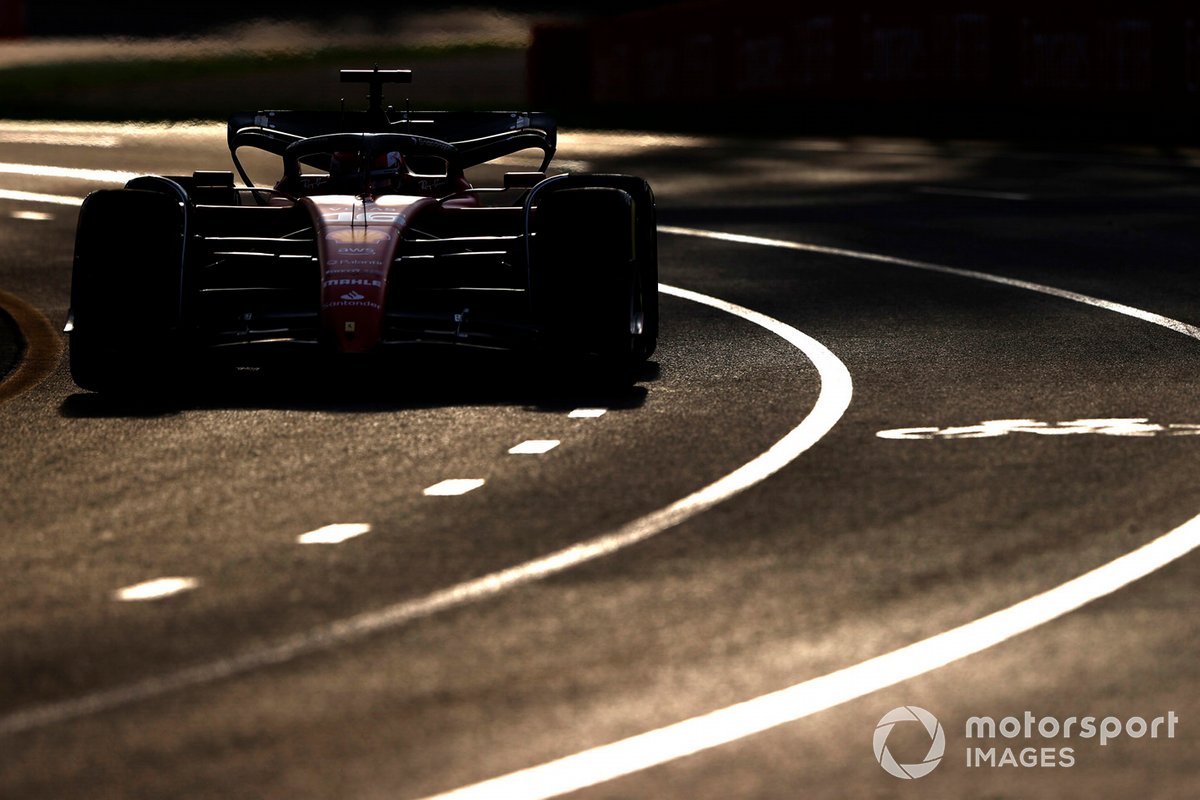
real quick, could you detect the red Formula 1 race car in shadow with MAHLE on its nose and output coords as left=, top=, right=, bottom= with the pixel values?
left=67, top=68, right=659, bottom=391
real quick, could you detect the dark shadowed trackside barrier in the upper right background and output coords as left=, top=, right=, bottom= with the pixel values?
left=529, top=0, right=1200, bottom=137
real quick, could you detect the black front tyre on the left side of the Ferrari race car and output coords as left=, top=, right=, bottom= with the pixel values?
left=70, top=190, right=184, bottom=393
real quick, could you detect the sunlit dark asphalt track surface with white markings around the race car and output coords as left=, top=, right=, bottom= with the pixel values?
left=0, top=125, right=1200, bottom=799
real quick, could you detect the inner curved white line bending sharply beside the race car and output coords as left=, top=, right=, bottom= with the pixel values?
left=0, top=285, right=853, bottom=735
